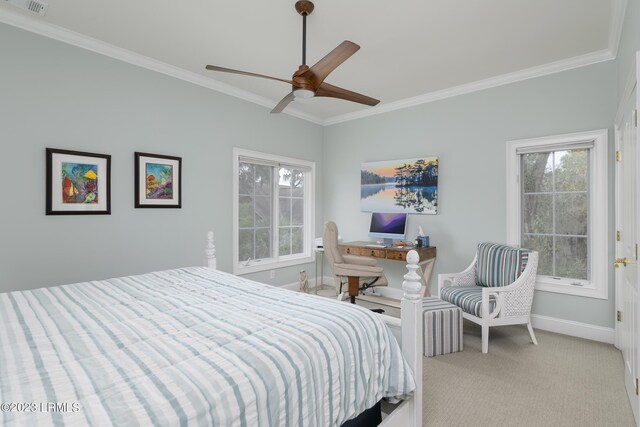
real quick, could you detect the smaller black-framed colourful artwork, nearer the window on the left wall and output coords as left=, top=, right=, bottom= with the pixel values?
left=135, top=153, right=182, bottom=208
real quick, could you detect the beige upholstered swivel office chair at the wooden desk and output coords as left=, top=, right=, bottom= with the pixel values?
left=322, top=221, right=388, bottom=303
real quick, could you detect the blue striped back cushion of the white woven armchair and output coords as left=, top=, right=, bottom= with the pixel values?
left=476, top=243, right=529, bottom=288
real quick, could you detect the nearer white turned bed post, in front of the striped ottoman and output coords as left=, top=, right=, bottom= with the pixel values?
left=400, top=250, right=422, bottom=427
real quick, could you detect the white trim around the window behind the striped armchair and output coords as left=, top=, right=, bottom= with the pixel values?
left=507, top=129, right=609, bottom=299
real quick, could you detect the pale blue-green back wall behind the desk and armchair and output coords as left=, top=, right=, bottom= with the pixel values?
left=324, top=61, right=617, bottom=327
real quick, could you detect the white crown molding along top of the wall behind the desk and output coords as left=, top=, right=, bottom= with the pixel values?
left=323, top=49, right=615, bottom=126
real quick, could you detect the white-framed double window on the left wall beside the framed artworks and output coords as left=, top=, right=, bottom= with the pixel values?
left=234, top=149, right=315, bottom=274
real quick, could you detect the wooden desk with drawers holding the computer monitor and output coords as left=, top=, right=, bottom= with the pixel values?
left=338, top=241, right=436, bottom=298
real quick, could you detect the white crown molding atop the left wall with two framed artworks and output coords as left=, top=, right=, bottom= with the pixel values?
left=0, top=6, right=323, bottom=125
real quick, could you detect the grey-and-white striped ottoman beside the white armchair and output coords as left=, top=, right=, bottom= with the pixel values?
left=422, top=297, right=463, bottom=357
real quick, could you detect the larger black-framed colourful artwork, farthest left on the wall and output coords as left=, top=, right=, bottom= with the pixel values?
left=46, top=148, right=111, bottom=215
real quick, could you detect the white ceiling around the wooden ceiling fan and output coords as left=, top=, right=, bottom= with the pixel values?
left=0, top=0, right=626, bottom=124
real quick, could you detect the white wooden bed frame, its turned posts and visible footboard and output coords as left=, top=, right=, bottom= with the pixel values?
left=205, top=231, right=422, bottom=427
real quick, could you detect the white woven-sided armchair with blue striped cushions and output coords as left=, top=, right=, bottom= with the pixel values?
left=438, top=243, right=538, bottom=353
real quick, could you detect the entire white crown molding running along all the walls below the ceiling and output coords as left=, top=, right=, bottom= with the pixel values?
left=0, top=0, right=628, bottom=126
